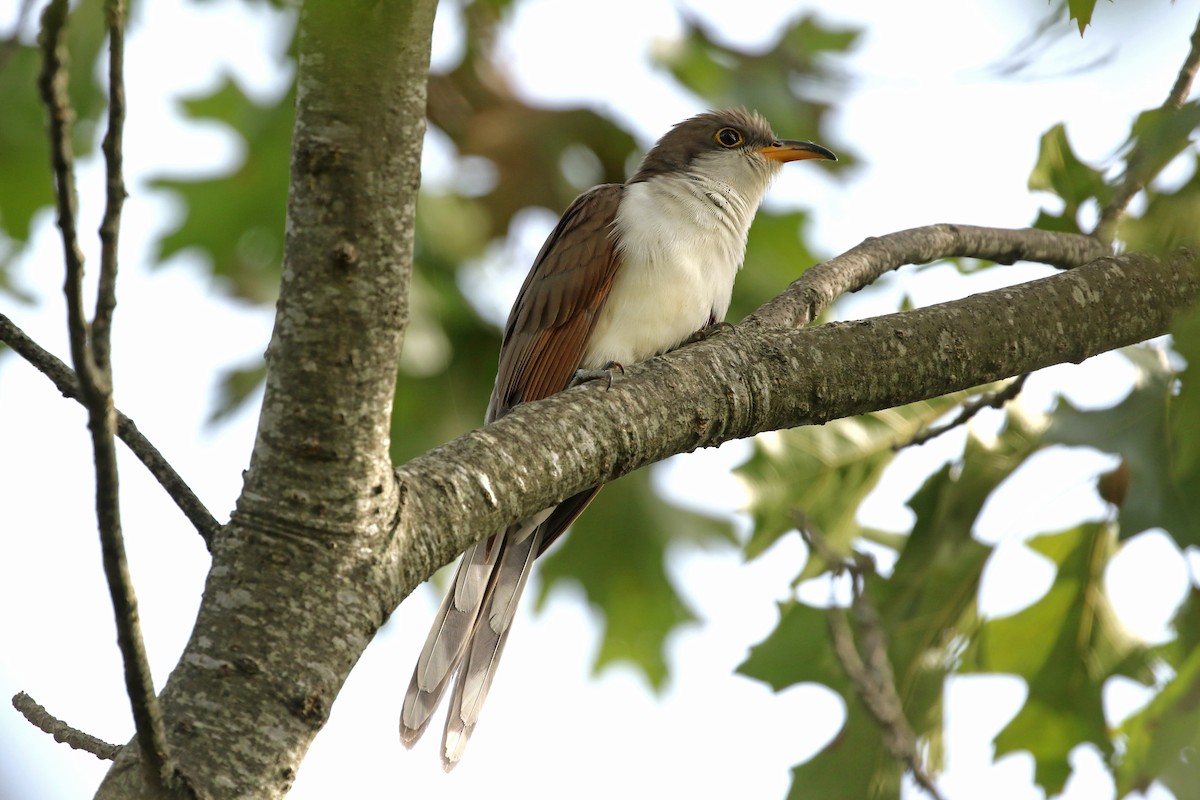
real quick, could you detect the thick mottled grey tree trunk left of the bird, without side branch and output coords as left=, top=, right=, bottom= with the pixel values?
left=97, top=0, right=436, bottom=799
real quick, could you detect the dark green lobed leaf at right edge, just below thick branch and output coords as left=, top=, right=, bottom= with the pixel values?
left=1045, top=347, right=1200, bottom=547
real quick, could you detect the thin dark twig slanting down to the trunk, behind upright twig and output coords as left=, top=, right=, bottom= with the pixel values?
left=0, top=314, right=221, bottom=548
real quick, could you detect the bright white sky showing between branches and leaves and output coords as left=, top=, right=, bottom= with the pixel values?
left=0, top=0, right=1200, bottom=800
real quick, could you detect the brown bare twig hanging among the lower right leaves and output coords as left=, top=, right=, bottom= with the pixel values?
left=796, top=513, right=942, bottom=800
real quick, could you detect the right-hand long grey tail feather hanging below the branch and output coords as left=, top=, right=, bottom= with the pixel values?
left=442, top=528, right=544, bottom=770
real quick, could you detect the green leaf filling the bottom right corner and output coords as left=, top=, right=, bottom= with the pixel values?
left=1116, top=649, right=1200, bottom=800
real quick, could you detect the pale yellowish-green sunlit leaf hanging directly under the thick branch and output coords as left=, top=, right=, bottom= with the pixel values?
left=737, top=395, right=964, bottom=579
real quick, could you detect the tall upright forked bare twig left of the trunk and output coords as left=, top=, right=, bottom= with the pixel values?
left=38, top=0, right=175, bottom=796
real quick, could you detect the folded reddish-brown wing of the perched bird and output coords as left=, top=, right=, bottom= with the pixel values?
left=487, top=184, right=624, bottom=422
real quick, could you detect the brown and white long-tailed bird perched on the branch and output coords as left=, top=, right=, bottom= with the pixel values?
left=400, top=108, right=838, bottom=770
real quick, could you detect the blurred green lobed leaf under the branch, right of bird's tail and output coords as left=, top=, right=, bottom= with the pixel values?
left=538, top=470, right=733, bottom=690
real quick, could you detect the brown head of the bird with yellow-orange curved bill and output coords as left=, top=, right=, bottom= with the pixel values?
left=629, top=109, right=838, bottom=197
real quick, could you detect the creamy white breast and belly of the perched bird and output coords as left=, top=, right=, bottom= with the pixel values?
left=581, top=175, right=766, bottom=369
